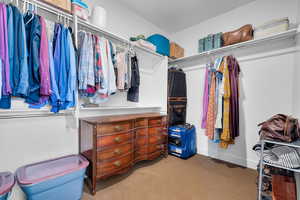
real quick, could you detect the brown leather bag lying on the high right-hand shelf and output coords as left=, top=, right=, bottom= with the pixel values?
left=222, top=24, right=253, bottom=46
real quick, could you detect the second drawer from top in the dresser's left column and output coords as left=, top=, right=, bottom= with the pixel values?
left=97, top=132, right=134, bottom=148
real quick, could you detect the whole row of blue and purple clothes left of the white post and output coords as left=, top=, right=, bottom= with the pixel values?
left=0, top=3, right=77, bottom=112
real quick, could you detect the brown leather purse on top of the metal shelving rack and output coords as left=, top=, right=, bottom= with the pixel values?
left=258, top=114, right=300, bottom=142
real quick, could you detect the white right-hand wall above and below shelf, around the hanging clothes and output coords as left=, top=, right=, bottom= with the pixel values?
left=171, top=0, right=297, bottom=168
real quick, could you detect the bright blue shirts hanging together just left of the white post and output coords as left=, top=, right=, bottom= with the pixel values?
left=50, top=24, right=77, bottom=112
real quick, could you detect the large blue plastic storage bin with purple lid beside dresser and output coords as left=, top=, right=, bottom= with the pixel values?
left=16, top=155, right=89, bottom=200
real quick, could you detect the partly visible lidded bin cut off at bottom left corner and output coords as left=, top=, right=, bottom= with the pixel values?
left=0, top=172, right=15, bottom=200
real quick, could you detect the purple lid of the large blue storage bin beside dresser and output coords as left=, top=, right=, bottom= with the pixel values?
left=16, top=155, right=89, bottom=185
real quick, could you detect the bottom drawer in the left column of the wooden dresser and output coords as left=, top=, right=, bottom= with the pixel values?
left=97, top=153, right=133, bottom=176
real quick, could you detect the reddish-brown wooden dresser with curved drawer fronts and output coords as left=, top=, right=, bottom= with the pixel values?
left=79, top=113, right=168, bottom=194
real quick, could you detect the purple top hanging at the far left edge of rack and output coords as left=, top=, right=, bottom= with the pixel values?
left=0, top=3, right=11, bottom=95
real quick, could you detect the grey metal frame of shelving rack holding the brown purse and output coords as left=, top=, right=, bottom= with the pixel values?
left=258, top=140, right=300, bottom=200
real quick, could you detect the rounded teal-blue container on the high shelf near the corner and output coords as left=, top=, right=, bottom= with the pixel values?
left=147, top=34, right=170, bottom=56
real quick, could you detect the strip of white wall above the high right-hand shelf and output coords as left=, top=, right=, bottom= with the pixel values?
left=170, top=0, right=298, bottom=56
